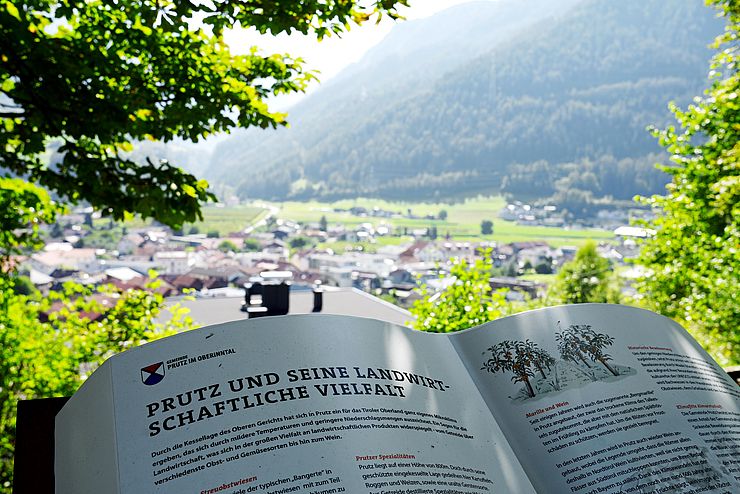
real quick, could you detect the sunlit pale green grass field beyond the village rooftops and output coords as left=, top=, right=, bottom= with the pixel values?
left=272, top=197, right=614, bottom=246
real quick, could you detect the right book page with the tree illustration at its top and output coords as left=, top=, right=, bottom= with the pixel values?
left=452, top=304, right=740, bottom=494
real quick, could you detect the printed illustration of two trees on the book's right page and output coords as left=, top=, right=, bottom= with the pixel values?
left=481, top=322, right=636, bottom=402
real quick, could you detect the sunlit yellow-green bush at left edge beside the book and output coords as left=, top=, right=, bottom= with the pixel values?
left=0, top=275, right=193, bottom=494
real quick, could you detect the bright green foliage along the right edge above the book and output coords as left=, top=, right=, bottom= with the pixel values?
left=638, top=0, right=740, bottom=365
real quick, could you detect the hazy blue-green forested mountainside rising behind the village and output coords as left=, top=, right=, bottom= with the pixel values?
left=206, top=0, right=721, bottom=206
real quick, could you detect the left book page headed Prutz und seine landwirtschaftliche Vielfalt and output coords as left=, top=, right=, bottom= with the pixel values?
left=105, top=315, right=534, bottom=494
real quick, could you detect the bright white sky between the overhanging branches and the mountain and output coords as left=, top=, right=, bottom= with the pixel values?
left=220, top=0, right=488, bottom=110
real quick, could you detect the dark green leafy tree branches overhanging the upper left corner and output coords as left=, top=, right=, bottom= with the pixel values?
left=0, top=0, right=406, bottom=226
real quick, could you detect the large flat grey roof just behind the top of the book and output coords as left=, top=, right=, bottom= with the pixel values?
left=160, top=287, right=414, bottom=326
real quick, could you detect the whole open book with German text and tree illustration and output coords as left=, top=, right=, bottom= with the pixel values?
left=55, top=304, right=740, bottom=494
